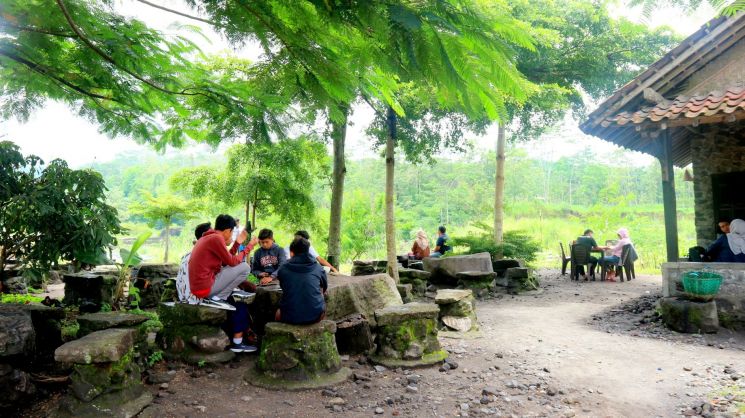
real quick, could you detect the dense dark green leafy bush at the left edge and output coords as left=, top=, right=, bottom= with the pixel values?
left=0, top=142, right=120, bottom=275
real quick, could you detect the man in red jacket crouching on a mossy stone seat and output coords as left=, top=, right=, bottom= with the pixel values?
left=189, top=215, right=258, bottom=353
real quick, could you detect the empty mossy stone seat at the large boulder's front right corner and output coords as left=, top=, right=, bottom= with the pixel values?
left=370, top=302, right=448, bottom=367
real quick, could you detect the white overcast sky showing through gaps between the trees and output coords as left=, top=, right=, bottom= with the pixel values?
left=0, top=0, right=714, bottom=167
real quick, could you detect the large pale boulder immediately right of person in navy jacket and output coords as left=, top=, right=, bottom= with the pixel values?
left=326, top=274, right=403, bottom=326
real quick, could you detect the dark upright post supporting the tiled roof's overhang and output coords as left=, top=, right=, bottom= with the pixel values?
left=658, top=128, right=680, bottom=262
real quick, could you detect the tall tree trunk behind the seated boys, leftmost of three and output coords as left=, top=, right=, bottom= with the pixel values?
left=327, top=105, right=349, bottom=269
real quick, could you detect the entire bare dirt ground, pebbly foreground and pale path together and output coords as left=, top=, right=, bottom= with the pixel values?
left=25, top=271, right=745, bottom=417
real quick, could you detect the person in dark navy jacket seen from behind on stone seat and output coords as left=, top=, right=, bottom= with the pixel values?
left=274, top=237, right=328, bottom=325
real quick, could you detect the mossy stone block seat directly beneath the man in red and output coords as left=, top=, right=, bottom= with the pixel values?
left=158, top=302, right=235, bottom=364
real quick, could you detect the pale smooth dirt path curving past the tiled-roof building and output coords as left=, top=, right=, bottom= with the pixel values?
left=478, top=276, right=745, bottom=416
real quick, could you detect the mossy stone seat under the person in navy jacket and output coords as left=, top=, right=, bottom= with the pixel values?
left=244, top=320, right=352, bottom=390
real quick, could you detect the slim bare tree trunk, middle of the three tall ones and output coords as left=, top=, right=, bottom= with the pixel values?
left=385, top=106, right=398, bottom=283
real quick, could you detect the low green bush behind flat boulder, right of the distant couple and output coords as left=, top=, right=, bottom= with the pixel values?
left=451, top=223, right=541, bottom=262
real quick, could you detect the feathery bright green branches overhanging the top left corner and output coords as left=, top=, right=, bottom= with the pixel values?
left=0, top=0, right=262, bottom=149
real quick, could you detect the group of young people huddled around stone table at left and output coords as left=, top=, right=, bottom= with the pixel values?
left=176, top=215, right=336, bottom=353
